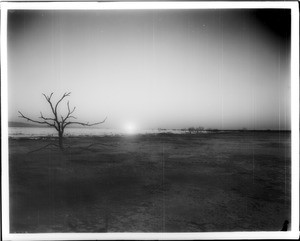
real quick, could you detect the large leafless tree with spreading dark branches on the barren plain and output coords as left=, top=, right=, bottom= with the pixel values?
left=18, top=92, right=106, bottom=149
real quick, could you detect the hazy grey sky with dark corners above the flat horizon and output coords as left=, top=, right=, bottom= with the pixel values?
left=8, top=10, right=291, bottom=129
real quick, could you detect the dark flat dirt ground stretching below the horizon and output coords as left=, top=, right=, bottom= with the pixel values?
left=9, top=132, right=291, bottom=233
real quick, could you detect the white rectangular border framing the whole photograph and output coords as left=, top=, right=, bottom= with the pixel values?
left=1, top=2, right=299, bottom=240
